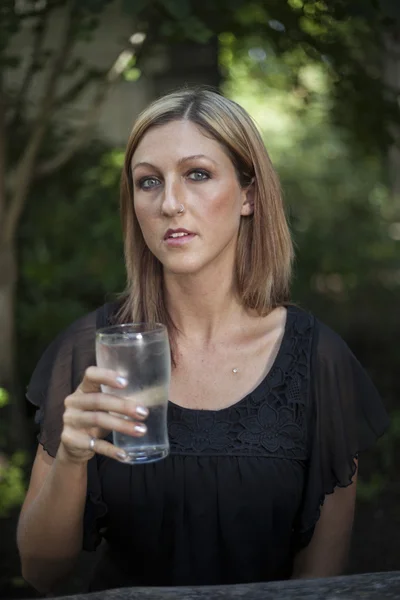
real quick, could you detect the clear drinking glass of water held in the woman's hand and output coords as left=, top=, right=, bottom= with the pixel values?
left=96, top=323, right=171, bottom=464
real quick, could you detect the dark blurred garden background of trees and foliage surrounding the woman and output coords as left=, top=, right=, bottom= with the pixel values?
left=0, top=0, right=400, bottom=598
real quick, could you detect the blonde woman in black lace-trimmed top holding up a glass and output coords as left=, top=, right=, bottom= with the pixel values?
left=18, top=90, right=387, bottom=592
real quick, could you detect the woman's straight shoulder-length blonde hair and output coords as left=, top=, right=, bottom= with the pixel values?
left=119, top=88, right=293, bottom=358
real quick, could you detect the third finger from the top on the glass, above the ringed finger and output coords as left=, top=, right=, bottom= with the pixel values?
left=63, top=408, right=147, bottom=437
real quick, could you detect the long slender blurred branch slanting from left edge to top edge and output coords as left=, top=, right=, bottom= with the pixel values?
left=3, top=1, right=76, bottom=243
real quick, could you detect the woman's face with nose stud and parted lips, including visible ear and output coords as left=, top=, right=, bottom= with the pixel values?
left=132, top=121, right=253, bottom=274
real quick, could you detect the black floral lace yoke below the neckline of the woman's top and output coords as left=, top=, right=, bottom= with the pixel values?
left=168, top=307, right=314, bottom=460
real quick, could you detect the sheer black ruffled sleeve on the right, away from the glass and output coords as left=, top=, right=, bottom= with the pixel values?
left=295, top=321, right=389, bottom=547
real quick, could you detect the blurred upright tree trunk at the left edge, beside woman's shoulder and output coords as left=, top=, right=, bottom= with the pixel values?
left=0, top=244, right=29, bottom=450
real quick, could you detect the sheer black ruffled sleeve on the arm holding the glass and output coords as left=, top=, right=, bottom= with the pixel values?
left=26, top=309, right=107, bottom=550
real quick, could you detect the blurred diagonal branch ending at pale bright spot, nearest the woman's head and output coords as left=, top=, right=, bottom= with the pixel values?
left=35, top=50, right=133, bottom=177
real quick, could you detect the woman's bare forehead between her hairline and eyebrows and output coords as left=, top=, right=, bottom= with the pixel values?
left=132, top=121, right=230, bottom=166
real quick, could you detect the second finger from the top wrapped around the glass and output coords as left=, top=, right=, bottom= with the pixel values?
left=65, top=392, right=149, bottom=421
